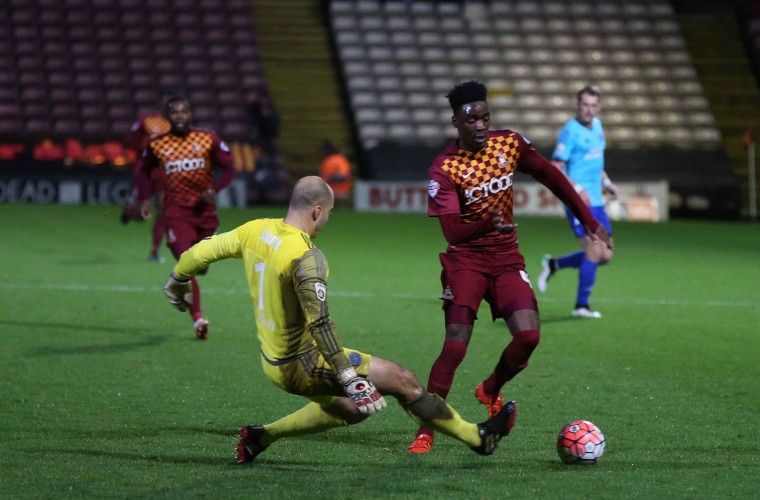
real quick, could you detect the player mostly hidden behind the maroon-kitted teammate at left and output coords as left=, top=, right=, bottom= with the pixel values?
left=121, top=109, right=171, bottom=263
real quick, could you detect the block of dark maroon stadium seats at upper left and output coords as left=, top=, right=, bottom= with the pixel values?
left=0, top=0, right=266, bottom=140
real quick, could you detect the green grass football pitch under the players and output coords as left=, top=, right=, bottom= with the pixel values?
left=0, top=205, right=760, bottom=498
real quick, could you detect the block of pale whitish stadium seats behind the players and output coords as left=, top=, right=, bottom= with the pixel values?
left=329, top=0, right=720, bottom=150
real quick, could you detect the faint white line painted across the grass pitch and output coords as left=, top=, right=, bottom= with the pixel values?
left=0, top=283, right=760, bottom=309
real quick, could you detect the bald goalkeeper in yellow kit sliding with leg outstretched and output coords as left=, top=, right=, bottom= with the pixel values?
left=164, top=176, right=514, bottom=463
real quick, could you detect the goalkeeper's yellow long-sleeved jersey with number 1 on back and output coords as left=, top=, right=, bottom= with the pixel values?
left=174, top=219, right=351, bottom=372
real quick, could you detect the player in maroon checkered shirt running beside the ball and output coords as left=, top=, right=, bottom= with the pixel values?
left=409, top=81, right=611, bottom=453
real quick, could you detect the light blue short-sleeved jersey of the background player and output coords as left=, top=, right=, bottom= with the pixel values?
left=552, top=118, right=607, bottom=207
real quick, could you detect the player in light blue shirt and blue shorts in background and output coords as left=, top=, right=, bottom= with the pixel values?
left=537, top=86, right=618, bottom=318
